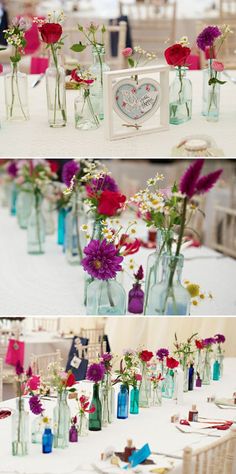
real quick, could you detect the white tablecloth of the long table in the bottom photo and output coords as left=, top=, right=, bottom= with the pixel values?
left=0, top=358, right=236, bottom=474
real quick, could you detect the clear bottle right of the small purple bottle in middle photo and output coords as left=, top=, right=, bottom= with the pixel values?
left=147, top=253, right=190, bottom=316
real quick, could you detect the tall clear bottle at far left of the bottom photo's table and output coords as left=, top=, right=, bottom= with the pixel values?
left=12, top=398, right=29, bottom=456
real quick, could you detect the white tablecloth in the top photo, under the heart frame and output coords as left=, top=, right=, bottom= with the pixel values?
left=0, top=71, right=236, bottom=158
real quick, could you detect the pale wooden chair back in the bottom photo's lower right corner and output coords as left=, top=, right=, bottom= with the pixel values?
left=182, top=427, right=236, bottom=474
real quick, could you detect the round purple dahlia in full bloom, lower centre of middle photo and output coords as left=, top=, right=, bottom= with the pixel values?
left=82, top=239, right=123, bottom=280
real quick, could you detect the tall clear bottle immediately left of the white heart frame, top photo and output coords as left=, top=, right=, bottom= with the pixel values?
left=90, top=44, right=110, bottom=120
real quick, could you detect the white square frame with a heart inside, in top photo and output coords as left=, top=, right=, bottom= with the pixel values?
left=103, top=65, right=169, bottom=140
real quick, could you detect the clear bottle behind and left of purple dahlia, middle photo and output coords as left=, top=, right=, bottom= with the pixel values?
left=65, top=193, right=87, bottom=265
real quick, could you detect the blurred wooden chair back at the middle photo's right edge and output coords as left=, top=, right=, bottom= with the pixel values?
left=212, top=206, right=236, bottom=258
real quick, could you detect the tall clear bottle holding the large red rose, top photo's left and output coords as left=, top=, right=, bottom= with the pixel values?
left=45, top=54, right=67, bottom=128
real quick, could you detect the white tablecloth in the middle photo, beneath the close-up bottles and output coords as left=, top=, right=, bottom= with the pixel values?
left=0, top=209, right=236, bottom=316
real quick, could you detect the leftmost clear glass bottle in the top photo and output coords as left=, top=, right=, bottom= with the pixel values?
left=5, top=64, right=29, bottom=121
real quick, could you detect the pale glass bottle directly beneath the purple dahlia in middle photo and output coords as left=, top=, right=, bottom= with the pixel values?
left=86, top=280, right=126, bottom=316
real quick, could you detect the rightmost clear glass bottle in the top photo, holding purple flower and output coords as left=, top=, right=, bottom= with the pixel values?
left=202, top=59, right=221, bottom=122
